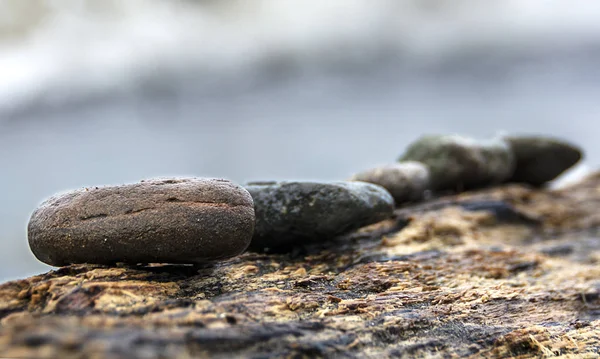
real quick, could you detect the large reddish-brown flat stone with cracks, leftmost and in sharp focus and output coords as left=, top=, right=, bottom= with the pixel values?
left=28, top=178, right=254, bottom=266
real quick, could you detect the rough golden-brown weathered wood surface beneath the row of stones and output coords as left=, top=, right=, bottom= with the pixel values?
left=0, top=174, right=600, bottom=358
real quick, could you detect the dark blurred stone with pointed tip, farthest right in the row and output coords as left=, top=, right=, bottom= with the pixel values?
left=504, top=136, right=583, bottom=186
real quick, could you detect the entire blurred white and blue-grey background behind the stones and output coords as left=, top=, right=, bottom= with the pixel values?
left=0, top=0, right=600, bottom=281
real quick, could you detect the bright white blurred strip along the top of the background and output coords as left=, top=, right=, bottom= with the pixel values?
left=0, top=0, right=600, bottom=109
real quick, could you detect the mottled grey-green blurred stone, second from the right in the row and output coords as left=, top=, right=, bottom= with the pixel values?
left=400, top=135, right=515, bottom=190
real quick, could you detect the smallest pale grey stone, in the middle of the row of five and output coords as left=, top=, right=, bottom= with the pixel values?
left=350, top=161, right=429, bottom=204
